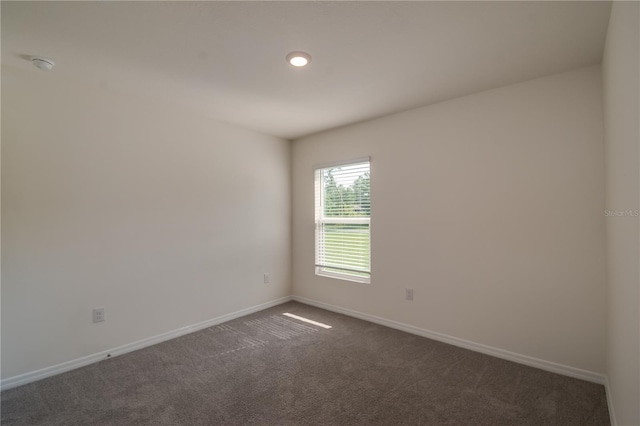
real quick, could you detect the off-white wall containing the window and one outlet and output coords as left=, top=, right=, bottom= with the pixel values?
left=293, top=66, right=606, bottom=374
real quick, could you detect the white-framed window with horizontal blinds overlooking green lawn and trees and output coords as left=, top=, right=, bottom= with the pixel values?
left=315, top=158, right=371, bottom=283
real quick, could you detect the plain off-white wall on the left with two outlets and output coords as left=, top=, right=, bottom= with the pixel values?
left=2, top=68, right=291, bottom=378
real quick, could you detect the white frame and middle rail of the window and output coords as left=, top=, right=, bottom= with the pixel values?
left=313, top=157, right=371, bottom=284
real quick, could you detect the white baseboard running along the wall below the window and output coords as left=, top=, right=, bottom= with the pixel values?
left=293, top=296, right=611, bottom=384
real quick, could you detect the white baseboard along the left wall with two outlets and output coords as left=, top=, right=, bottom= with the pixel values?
left=0, top=296, right=292, bottom=390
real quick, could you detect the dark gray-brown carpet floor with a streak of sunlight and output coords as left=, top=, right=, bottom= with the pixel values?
left=1, top=302, right=610, bottom=426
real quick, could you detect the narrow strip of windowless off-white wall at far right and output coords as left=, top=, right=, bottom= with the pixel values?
left=603, top=2, right=640, bottom=425
